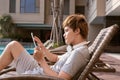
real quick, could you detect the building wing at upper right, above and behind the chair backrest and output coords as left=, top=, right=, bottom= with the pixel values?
left=86, top=0, right=120, bottom=52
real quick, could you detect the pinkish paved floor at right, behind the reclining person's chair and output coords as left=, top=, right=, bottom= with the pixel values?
left=95, top=53, right=120, bottom=80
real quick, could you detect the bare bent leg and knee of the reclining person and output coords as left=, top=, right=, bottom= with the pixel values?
left=0, top=41, right=24, bottom=71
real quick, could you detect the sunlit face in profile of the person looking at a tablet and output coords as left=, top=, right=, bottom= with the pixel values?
left=63, top=26, right=75, bottom=44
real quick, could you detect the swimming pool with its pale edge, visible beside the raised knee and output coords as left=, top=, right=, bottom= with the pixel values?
left=0, top=44, right=34, bottom=55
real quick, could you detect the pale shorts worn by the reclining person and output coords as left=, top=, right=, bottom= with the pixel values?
left=13, top=50, right=44, bottom=74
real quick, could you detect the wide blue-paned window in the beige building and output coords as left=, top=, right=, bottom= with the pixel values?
left=20, top=0, right=40, bottom=13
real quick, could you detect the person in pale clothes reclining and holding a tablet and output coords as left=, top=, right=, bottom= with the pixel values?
left=0, top=14, right=90, bottom=80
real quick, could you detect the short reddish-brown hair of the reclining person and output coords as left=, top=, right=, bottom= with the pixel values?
left=63, top=14, right=88, bottom=39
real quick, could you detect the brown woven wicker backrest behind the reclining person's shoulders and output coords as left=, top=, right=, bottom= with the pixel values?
left=77, top=24, right=119, bottom=80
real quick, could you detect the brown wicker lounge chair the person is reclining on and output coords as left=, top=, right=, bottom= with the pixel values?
left=0, top=24, right=119, bottom=80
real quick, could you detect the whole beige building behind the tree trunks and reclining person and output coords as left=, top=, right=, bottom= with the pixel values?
left=0, top=0, right=120, bottom=52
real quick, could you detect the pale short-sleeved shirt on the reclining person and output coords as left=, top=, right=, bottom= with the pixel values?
left=51, top=43, right=90, bottom=76
